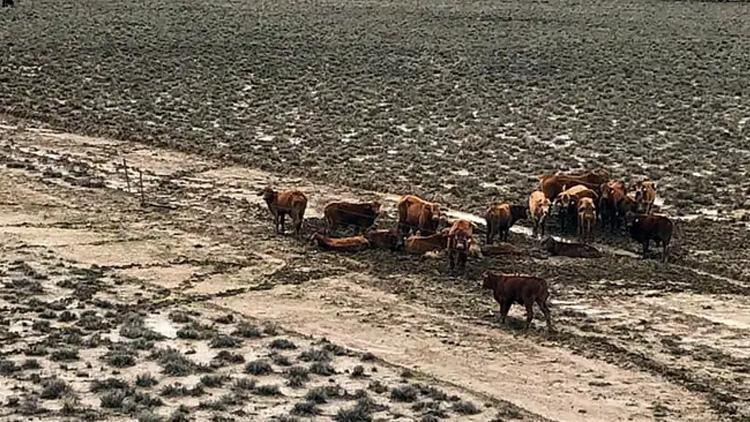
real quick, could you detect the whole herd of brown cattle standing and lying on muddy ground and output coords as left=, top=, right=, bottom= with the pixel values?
left=259, top=169, right=673, bottom=327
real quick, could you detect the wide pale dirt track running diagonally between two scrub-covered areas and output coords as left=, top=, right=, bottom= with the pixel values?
left=0, top=126, right=750, bottom=421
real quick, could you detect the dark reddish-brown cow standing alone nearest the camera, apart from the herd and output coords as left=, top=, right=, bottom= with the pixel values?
left=482, top=272, right=552, bottom=329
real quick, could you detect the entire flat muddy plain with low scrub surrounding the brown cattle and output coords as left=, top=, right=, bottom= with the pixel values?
left=0, top=0, right=750, bottom=421
